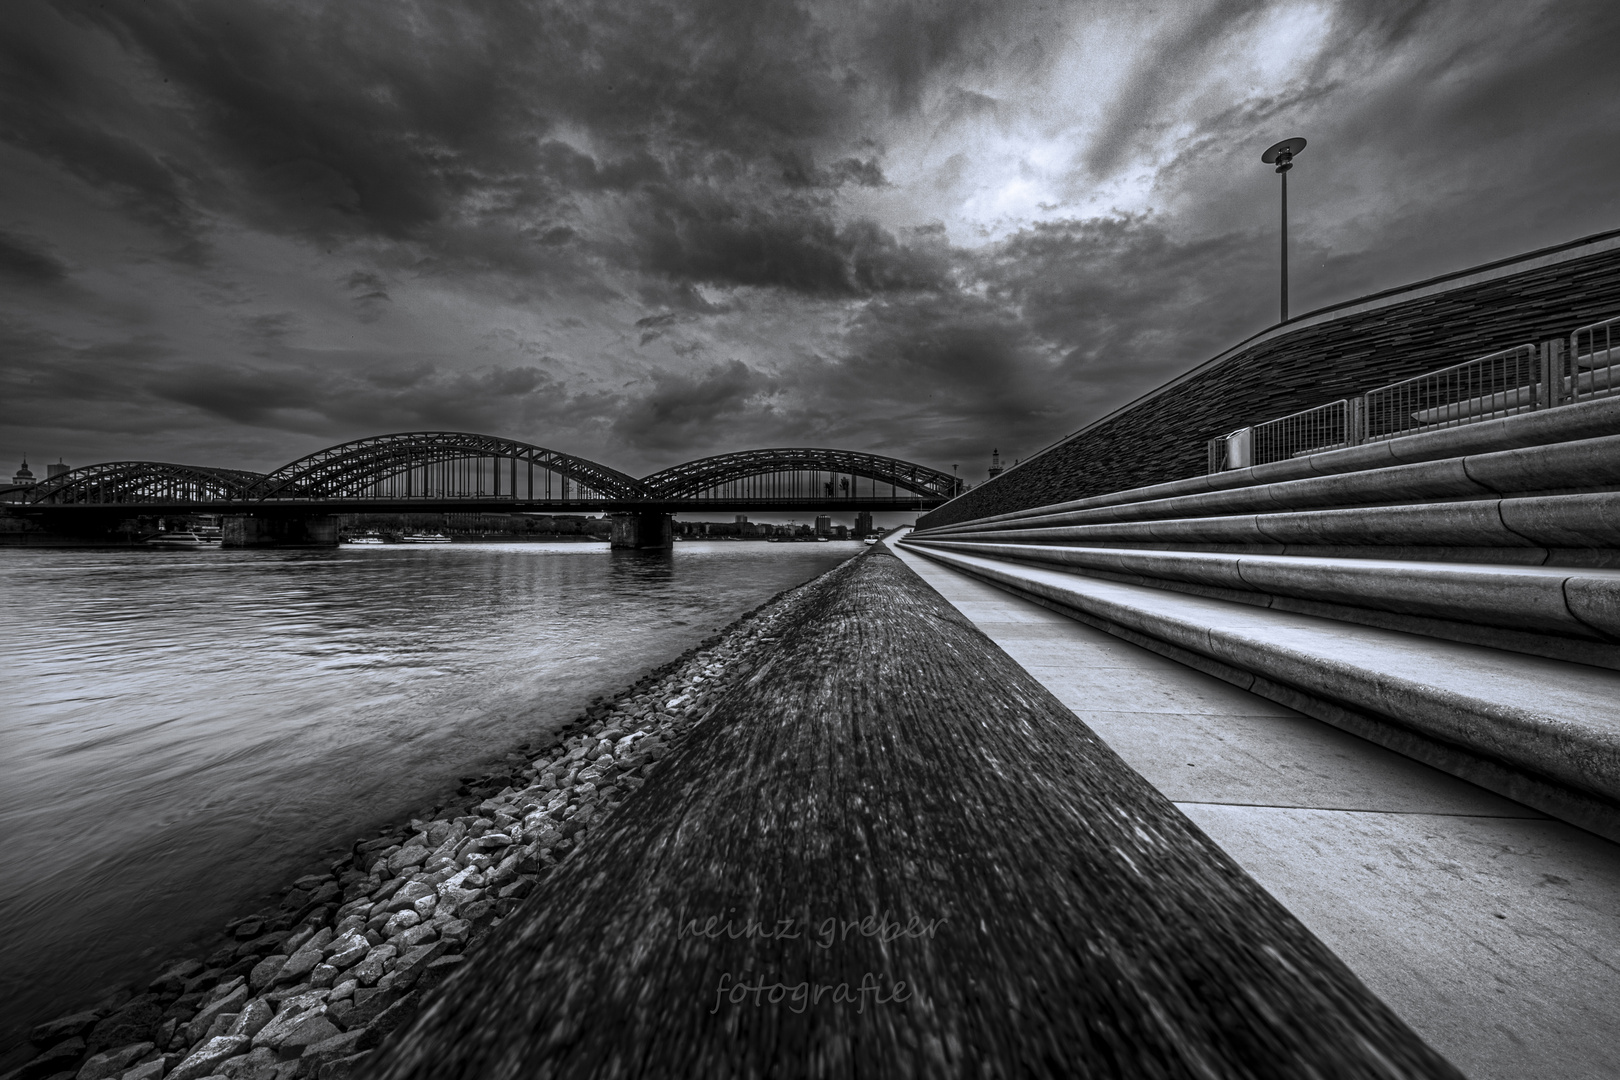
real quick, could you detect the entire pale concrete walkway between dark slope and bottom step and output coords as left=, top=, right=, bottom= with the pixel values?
left=896, top=547, right=1620, bottom=1080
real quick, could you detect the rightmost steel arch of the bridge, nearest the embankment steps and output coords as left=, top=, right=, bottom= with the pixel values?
left=642, top=447, right=959, bottom=499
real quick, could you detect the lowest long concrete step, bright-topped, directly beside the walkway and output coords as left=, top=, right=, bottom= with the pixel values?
left=904, top=539, right=1620, bottom=840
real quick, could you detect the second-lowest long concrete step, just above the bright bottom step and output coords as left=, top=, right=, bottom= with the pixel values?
left=909, top=539, right=1620, bottom=669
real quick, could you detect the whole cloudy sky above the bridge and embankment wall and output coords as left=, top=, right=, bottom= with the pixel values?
left=0, top=0, right=1620, bottom=479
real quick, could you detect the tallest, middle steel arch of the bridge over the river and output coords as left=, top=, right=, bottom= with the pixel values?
left=246, top=431, right=646, bottom=500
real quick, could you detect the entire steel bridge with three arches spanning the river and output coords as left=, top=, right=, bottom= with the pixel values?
left=22, top=431, right=961, bottom=513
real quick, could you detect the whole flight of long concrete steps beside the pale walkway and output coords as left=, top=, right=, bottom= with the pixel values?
left=904, top=397, right=1620, bottom=840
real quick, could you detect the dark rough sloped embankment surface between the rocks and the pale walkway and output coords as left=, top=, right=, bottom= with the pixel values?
left=368, top=547, right=1458, bottom=1080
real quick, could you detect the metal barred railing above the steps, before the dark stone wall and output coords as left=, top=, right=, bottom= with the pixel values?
left=1205, top=317, right=1620, bottom=473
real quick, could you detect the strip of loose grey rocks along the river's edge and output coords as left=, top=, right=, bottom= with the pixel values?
left=0, top=555, right=860, bottom=1080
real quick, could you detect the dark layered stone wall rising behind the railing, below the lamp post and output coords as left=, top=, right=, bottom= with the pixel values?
left=917, top=238, right=1620, bottom=528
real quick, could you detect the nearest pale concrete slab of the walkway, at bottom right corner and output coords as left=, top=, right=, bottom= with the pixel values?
left=1178, top=803, right=1620, bottom=1080
